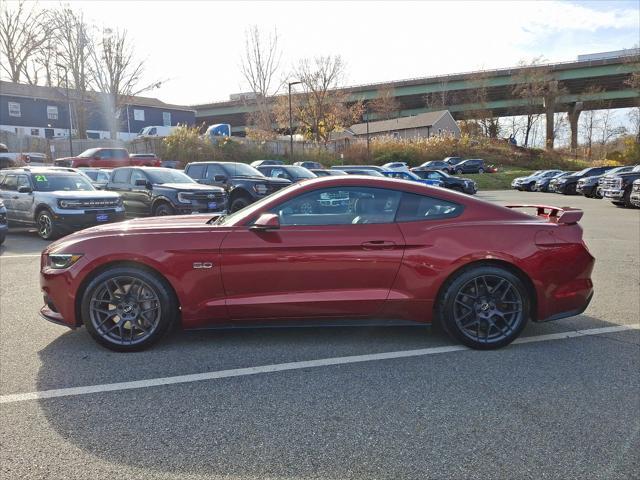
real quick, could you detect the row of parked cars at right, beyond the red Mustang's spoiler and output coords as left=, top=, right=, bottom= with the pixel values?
left=511, top=165, right=640, bottom=208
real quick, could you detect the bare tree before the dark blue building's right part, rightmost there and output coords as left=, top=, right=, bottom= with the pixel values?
left=89, top=29, right=161, bottom=139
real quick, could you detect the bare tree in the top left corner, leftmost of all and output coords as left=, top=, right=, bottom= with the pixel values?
left=0, top=1, right=49, bottom=83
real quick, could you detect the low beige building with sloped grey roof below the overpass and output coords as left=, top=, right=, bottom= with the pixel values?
left=348, top=110, right=460, bottom=138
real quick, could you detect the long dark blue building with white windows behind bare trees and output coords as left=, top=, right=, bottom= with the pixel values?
left=0, top=81, right=195, bottom=140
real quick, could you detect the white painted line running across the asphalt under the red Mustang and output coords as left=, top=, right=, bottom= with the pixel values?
left=0, top=325, right=640, bottom=404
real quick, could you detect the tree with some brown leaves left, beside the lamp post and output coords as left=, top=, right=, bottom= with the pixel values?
left=276, top=56, right=363, bottom=143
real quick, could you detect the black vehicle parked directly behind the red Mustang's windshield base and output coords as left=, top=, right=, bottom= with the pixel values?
left=184, top=162, right=291, bottom=212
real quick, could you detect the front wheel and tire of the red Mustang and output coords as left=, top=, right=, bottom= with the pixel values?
left=81, top=266, right=178, bottom=352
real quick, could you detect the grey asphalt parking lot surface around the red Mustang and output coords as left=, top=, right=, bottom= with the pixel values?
left=0, top=191, right=640, bottom=480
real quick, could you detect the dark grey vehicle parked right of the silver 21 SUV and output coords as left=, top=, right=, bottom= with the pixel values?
left=105, top=167, right=227, bottom=216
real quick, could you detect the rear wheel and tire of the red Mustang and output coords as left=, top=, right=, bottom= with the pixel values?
left=437, top=265, right=531, bottom=350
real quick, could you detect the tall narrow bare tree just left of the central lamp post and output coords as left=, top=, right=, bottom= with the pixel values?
left=240, top=25, right=282, bottom=132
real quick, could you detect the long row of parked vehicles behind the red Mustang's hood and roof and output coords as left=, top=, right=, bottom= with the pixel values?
left=0, top=155, right=477, bottom=240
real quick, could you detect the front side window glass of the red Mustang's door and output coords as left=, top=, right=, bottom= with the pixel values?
left=271, top=187, right=402, bottom=226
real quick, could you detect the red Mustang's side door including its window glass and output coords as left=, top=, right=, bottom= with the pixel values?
left=221, top=187, right=404, bottom=322
